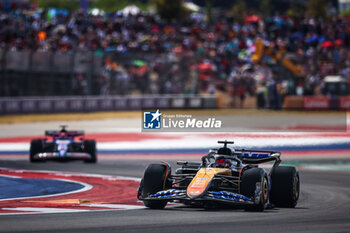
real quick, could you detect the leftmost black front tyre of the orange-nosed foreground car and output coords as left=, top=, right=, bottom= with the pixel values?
left=142, top=164, right=170, bottom=209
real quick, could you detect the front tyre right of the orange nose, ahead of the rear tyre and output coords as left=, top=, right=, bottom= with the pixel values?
left=240, top=168, right=269, bottom=211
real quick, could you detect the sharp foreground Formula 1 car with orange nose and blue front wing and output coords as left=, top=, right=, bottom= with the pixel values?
left=138, top=141, right=300, bottom=211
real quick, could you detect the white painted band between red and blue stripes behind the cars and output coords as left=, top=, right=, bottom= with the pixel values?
left=0, top=135, right=349, bottom=152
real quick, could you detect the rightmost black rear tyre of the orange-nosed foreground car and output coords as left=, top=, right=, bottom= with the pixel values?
left=270, top=166, right=300, bottom=208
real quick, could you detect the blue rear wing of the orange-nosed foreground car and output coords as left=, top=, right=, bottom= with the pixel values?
left=234, top=150, right=281, bottom=166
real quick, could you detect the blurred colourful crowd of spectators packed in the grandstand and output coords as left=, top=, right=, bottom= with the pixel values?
left=0, top=6, right=350, bottom=108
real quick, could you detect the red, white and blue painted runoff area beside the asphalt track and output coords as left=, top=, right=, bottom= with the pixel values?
left=0, top=109, right=350, bottom=215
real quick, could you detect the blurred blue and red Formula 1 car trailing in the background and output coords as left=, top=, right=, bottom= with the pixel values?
left=29, top=126, right=97, bottom=163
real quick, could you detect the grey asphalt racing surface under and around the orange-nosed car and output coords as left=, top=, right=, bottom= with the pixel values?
left=0, top=159, right=350, bottom=233
